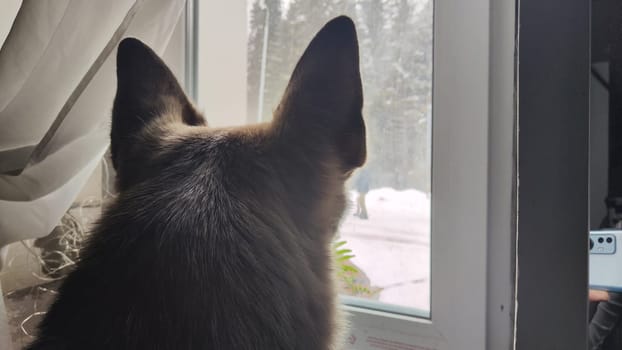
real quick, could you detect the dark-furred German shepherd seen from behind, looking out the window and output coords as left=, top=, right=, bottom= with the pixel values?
left=29, top=17, right=366, bottom=350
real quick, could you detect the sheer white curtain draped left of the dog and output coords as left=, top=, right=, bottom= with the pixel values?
left=0, top=0, right=185, bottom=349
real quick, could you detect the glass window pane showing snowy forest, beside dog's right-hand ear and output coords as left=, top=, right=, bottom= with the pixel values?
left=247, top=0, right=433, bottom=316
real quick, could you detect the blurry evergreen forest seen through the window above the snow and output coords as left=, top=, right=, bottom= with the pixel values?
left=247, top=0, right=433, bottom=192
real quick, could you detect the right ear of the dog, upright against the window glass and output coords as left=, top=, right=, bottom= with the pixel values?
left=275, top=16, right=366, bottom=171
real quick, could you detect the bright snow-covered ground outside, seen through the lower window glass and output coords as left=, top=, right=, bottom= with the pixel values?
left=340, top=188, right=430, bottom=310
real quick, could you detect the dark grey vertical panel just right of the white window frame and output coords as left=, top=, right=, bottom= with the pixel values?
left=516, top=0, right=590, bottom=350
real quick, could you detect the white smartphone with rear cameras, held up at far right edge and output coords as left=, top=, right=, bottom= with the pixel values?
left=589, top=230, right=622, bottom=292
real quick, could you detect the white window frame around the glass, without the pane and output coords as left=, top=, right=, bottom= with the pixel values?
left=189, top=0, right=516, bottom=350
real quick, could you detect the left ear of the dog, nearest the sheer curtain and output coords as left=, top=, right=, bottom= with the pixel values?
left=110, top=38, right=204, bottom=183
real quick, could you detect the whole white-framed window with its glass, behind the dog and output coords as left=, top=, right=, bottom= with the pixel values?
left=194, top=0, right=514, bottom=349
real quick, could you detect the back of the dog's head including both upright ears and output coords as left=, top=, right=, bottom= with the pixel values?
left=111, top=17, right=366, bottom=235
